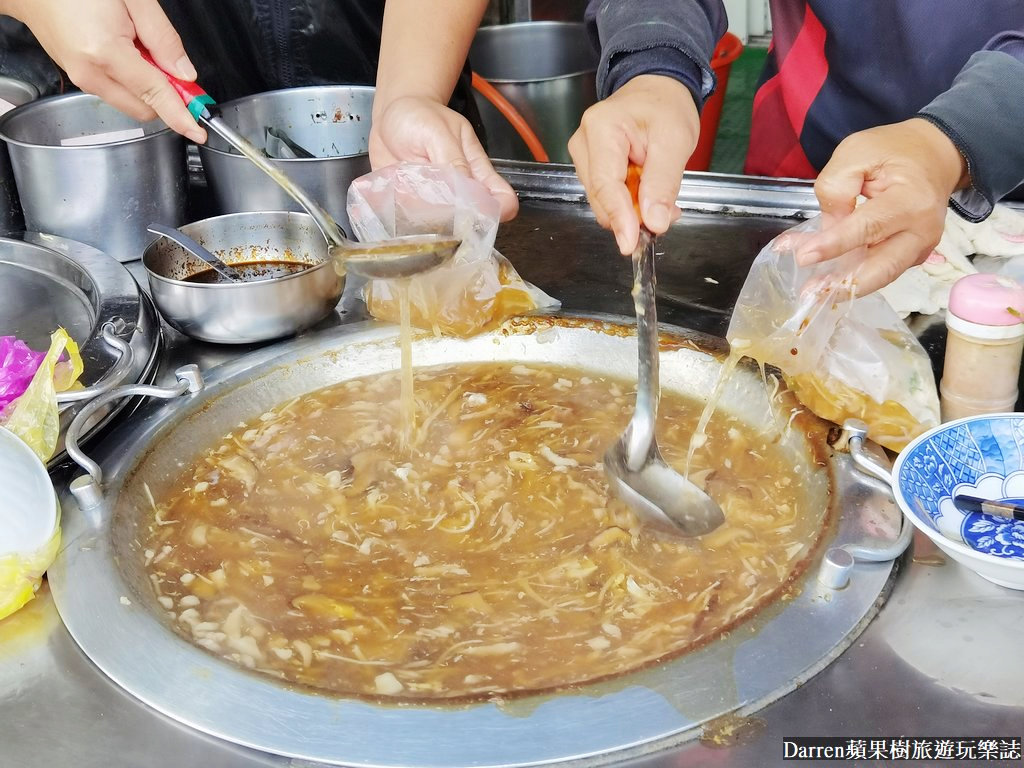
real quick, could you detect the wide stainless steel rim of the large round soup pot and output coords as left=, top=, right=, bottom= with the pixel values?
left=49, top=317, right=900, bottom=768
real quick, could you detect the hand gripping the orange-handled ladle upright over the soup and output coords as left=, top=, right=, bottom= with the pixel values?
left=569, top=75, right=700, bottom=255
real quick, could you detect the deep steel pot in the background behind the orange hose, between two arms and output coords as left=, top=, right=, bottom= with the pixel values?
left=469, top=22, right=598, bottom=163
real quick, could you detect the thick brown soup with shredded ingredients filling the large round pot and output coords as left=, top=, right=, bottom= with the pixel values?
left=145, top=364, right=824, bottom=699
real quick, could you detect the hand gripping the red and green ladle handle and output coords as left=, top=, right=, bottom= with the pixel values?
left=7, top=0, right=206, bottom=143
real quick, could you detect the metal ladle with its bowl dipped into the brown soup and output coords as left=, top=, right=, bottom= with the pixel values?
left=604, top=225, right=725, bottom=536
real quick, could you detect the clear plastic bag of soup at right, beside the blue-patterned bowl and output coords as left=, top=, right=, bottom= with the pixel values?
left=726, top=217, right=939, bottom=451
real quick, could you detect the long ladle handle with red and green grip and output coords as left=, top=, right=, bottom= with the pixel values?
left=135, top=40, right=351, bottom=246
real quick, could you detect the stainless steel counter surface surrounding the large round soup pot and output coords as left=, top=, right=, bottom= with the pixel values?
left=0, top=166, right=1024, bottom=768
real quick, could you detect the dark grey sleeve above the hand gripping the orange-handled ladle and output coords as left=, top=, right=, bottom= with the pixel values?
left=586, top=0, right=728, bottom=108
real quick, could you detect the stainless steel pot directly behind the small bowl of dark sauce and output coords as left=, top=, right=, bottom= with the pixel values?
left=200, top=85, right=374, bottom=234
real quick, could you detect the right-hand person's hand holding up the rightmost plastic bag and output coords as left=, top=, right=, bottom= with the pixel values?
left=796, top=118, right=969, bottom=295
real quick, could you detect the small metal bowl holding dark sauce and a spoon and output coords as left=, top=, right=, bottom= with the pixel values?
left=142, top=211, right=345, bottom=344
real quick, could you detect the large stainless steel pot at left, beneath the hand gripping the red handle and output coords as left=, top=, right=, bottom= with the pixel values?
left=0, top=93, right=188, bottom=261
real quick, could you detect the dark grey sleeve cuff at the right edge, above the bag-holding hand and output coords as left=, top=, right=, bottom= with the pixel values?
left=919, top=45, right=1024, bottom=221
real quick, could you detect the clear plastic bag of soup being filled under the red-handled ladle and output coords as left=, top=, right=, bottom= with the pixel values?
left=348, top=164, right=558, bottom=336
